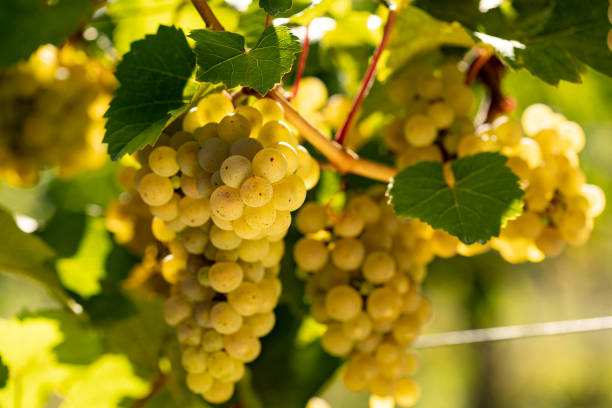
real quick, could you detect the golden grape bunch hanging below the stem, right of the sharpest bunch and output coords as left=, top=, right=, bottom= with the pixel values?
left=293, top=188, right=434, bottom=407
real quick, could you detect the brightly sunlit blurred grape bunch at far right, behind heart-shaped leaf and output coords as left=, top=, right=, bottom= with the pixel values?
left=458, top=104, right=605, bottom=263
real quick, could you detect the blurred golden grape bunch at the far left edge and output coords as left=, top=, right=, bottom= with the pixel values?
left=0, top=45, right=114, bottom=187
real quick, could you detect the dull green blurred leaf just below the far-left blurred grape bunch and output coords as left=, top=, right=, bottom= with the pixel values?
left=47, top=162, right=121, bottom=212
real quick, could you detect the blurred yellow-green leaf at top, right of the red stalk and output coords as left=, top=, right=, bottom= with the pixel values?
left=378, top=6, right=474, bottom=79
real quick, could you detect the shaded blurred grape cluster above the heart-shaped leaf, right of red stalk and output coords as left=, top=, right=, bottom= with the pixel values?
left=383, top=62, right=474, bottom=169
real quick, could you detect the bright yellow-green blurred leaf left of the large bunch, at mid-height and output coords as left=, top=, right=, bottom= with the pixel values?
left=56, top=217, right=112, bottom=298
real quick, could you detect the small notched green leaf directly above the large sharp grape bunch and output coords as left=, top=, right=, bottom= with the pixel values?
left=189, top=26, right=301, bottom=95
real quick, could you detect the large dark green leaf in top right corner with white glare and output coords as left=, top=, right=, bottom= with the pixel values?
left=414, top=0, right=612, bottom=85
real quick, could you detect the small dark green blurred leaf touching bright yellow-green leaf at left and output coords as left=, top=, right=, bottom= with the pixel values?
left=36, top=212, right=87, bottom=257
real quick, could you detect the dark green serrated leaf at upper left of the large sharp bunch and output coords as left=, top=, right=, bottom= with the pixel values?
left=104, top=26, right=195, bottom=160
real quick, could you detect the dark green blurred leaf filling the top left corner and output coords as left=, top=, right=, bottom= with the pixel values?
left=0, top=0, right=92, bottom=67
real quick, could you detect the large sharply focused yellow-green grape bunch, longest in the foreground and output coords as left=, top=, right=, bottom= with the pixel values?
left=135, top=93, right=319, bottom=403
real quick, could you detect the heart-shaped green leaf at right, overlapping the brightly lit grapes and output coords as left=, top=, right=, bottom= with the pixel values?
left=390, top=153, right=523, bottom=244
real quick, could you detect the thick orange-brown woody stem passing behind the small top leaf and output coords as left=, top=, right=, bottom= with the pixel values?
left=191, top=0, right=397, bottom=182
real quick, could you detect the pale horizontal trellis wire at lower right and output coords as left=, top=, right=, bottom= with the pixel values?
left=413, top=316, right=612, bottom=348
